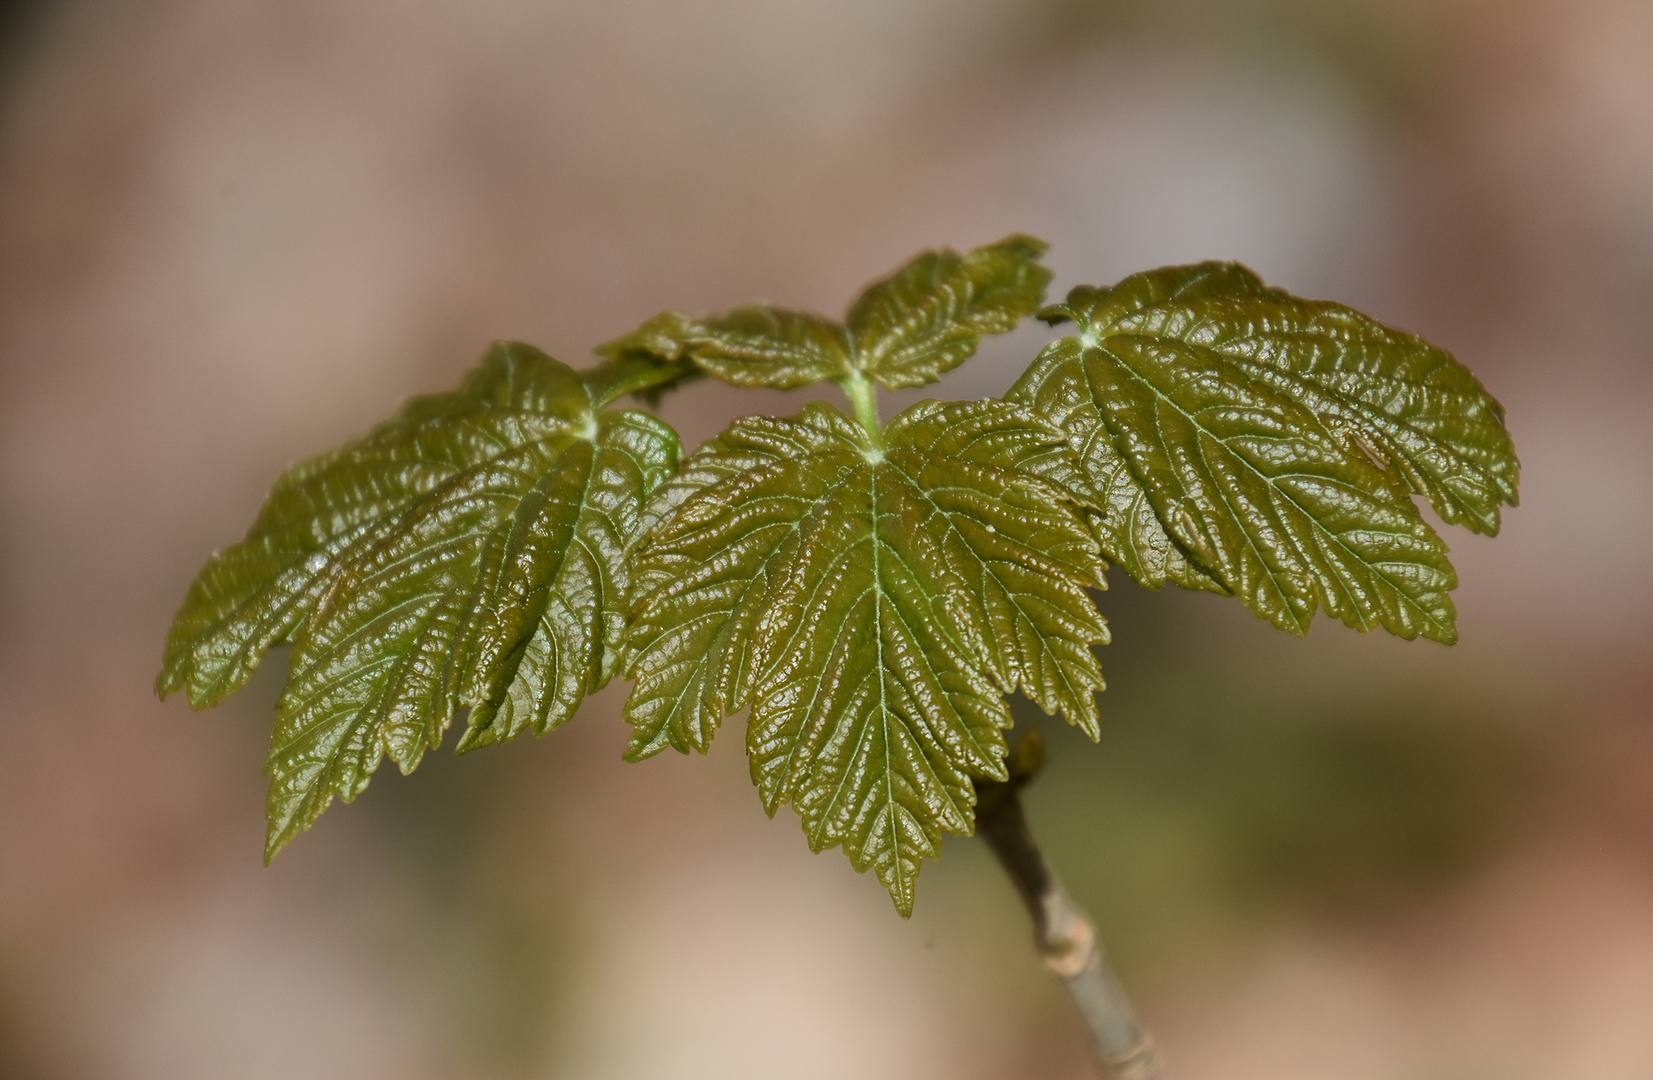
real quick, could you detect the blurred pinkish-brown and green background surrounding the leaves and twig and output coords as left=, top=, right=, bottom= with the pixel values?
left=0, top=0, right=1653, bottom=1080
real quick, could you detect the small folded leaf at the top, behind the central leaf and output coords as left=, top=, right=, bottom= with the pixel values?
left=597, top=235, right=1050, bottom=389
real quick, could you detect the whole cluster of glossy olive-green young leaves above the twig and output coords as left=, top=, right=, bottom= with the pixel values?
left=157, top=237, right=1519, bottom=915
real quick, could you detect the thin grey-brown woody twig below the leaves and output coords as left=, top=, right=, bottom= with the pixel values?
left=975, top=728, right=1164, bottom=1080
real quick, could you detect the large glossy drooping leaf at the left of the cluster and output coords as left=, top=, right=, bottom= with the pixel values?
left=157, top=342, right=681, bottom=858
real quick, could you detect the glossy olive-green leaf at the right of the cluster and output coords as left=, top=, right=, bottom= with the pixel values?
left=1008, top=263, right=1519, bottom=642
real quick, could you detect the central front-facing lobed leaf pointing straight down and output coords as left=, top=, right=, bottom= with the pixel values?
left=625, top=402, right=1106, bottom=915
